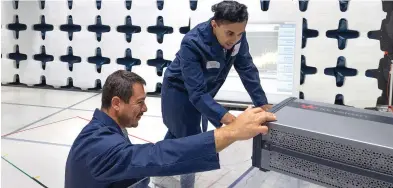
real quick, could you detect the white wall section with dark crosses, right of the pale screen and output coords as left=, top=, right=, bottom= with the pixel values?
left=300, top=0, right=386, bottom=108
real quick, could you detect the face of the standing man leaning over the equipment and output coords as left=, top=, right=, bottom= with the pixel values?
left=211, top=20, right=247, bottom=50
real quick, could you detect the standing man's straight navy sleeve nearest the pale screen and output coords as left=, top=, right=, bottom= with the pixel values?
left=234, top=34, right=268, bottom=107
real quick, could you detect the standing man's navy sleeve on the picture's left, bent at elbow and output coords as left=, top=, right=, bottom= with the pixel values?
left=178, top=40, right=227, bottom=125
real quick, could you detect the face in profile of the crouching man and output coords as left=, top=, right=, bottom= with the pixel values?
left=117, top=83, right=147, bottom=127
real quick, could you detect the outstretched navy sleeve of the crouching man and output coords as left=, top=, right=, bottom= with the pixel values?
left=86, top=129, right=220, bottom=182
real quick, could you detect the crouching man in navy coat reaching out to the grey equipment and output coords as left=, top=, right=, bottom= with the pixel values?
left=65, top=70, right=276, bottom=188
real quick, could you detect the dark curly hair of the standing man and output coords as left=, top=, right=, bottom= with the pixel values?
left=212, top=0, right=248, bottom=23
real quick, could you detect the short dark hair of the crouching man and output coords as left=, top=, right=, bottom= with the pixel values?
left=101, top=70, right=146, bottom=109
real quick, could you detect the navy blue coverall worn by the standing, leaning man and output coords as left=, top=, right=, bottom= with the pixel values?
left=161, top=19, right=268, bottom=139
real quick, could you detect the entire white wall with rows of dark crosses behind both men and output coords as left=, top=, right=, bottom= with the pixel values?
left=1, top=0, right=391, bottom=108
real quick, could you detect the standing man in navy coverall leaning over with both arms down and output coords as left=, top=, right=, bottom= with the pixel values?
left=161, top=1, right=272, bottom=188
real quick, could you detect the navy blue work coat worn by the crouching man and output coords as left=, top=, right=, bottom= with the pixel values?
left=65, top=109, right=220, bottom=188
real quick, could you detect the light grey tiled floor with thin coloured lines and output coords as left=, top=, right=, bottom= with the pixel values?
left=1, top=86, right=322, bottom=188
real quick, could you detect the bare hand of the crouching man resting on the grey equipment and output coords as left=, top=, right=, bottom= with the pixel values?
left=214, top=107, right=276, bottom=152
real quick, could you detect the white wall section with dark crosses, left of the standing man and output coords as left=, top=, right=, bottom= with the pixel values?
left=2, top=0, right=192, bottom=92
